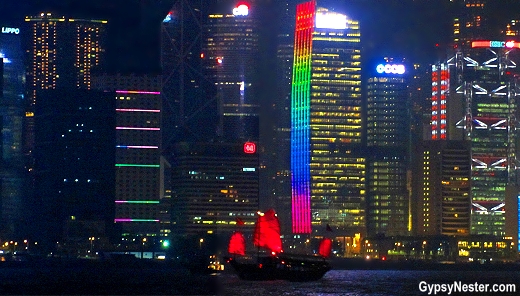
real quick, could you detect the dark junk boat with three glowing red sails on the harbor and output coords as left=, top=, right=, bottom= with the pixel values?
left=226, top=210, right=332, bottom=281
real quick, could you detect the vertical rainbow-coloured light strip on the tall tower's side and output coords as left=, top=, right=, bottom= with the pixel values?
left=291, top=0, right=316, bottom=233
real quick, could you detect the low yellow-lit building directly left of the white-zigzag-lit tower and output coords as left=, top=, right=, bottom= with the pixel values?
left=412, top=140, right=471, bottom=236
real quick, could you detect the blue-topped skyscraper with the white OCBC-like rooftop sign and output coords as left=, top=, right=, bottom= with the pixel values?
left=366, top=59, right=410, bottom=236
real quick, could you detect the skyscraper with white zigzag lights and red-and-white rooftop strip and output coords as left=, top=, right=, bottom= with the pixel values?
left=452, top=41, right=520, bottom=235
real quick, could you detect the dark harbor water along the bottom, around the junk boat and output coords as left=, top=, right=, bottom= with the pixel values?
left=0, top=260, right=520, bottom=296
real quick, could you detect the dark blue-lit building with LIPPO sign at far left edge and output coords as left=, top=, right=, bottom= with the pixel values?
left=0, top=23, right=25, bottom=237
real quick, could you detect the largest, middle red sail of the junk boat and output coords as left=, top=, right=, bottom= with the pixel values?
left=253, top=209, right=282, bottom=253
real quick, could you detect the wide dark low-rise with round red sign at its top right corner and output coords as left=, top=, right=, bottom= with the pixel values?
left=172, top=142, right=259, bottom=239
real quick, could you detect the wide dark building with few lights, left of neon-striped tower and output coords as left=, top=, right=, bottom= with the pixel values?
left=33, top=89, right=116, bottom=251
